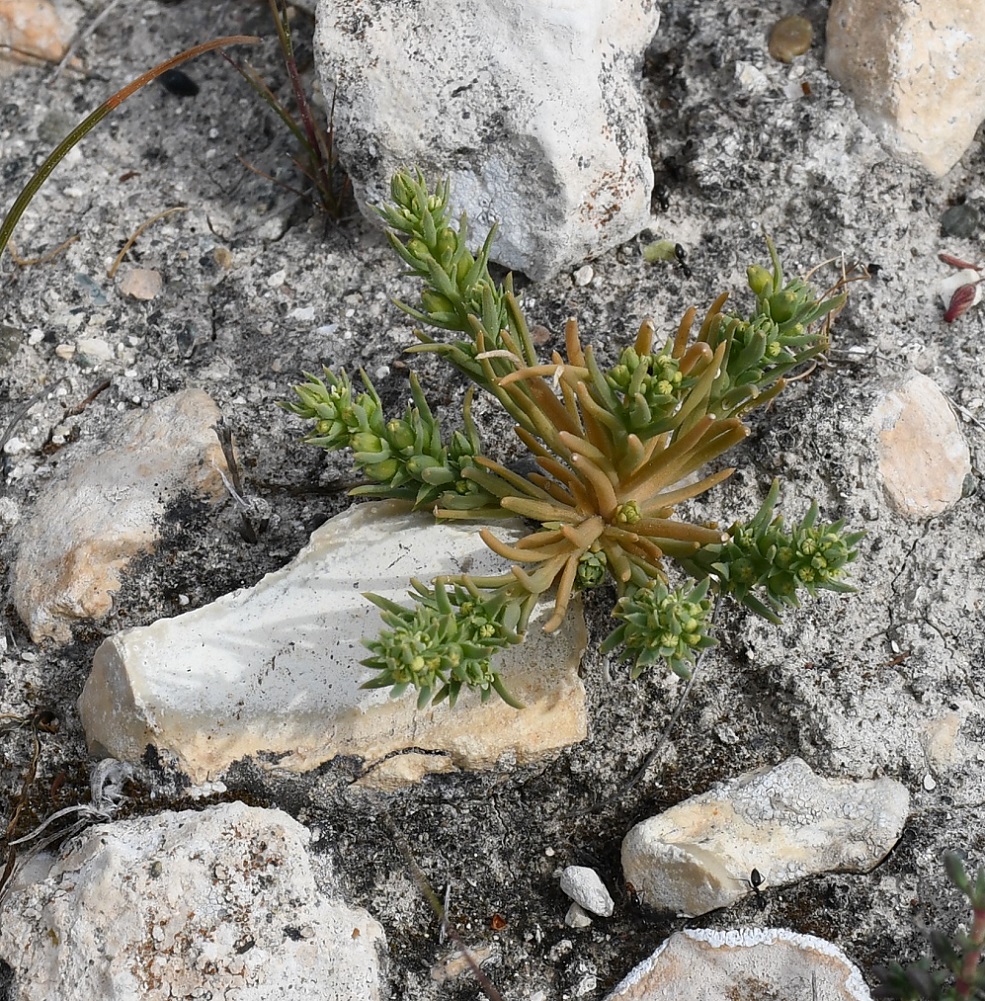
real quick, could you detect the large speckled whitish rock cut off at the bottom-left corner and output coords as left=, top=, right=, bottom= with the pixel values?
left=0, top=803, right=383, bottom=1001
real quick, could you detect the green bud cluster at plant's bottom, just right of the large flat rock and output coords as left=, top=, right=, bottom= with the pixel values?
left=602, top=578, right=716, bottom=679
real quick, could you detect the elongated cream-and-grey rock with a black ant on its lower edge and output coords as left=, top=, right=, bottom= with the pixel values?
left=623, top=758, right=910, bottom=917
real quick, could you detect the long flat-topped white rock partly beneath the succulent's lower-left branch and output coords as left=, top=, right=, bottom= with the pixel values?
left=80, top=502, right=587, bottom=784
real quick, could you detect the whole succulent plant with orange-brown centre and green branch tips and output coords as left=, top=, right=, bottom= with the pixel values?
left=281, top=172, right=861, bottom=706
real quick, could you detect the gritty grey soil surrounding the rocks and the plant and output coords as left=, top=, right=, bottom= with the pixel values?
left=0, top=0, right=985, bottom=1001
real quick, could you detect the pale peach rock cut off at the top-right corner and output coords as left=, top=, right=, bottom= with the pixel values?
left=826, top=0, right=985, bottom=177
